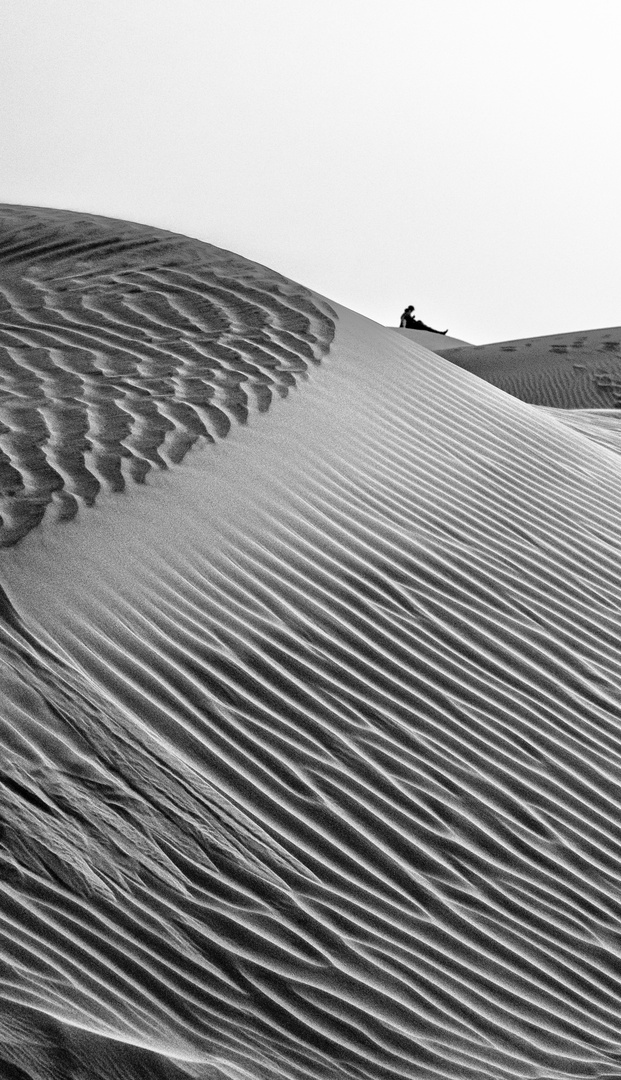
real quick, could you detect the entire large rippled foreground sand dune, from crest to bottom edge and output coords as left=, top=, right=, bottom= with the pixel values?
left=0, top=207, right=621, bottom=1080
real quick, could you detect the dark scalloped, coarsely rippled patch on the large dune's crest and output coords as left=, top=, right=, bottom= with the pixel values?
left=0, top=206, right=334, bottom=546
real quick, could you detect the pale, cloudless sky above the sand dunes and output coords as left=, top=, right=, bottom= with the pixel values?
left=0, top=0, right=621, bottom=343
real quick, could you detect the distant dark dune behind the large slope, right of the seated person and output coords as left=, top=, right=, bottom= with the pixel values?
left=436, top=326, right=621, bottom=408
